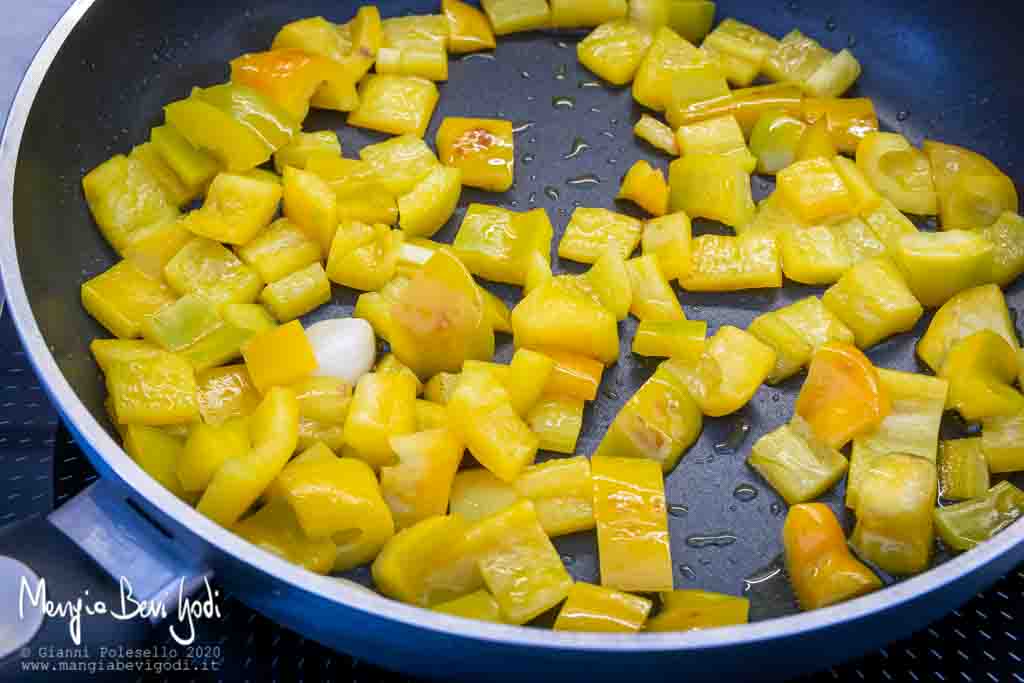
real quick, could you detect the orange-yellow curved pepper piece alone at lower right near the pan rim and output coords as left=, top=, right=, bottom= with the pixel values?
left=782, top=503, right=882, bottom=610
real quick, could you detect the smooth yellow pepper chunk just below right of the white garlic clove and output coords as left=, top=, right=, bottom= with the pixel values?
left=345, top=373, right=417, bottom=469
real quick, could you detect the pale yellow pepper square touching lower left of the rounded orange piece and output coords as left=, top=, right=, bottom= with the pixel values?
left=746, top=416, right=849, bottom=505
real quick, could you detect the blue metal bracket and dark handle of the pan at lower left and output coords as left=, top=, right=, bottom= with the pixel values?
left=0, top=479, right=216, bottom=678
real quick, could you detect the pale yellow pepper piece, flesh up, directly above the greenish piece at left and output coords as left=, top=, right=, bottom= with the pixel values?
left=164, top=238, right=263, bottom=304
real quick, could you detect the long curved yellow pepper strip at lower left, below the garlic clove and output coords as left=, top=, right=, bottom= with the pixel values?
left=197, top=387, right=299, bottom=526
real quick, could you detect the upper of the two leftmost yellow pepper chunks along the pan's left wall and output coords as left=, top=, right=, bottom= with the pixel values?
left=82, top=155, right=178, bottom=252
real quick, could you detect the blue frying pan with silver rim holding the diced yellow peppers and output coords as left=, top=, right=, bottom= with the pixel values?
left=0, top=0, right=1024, bottom=681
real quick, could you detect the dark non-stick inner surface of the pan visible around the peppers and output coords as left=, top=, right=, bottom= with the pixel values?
left=14, top=0, right=1024, bottom=617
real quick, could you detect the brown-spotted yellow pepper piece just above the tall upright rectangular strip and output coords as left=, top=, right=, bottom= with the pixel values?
left=596, top=364, right=703, bottom=472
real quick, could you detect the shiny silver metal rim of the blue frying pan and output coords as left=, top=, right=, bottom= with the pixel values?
left=0, top=0, right=1024, bottom=653
